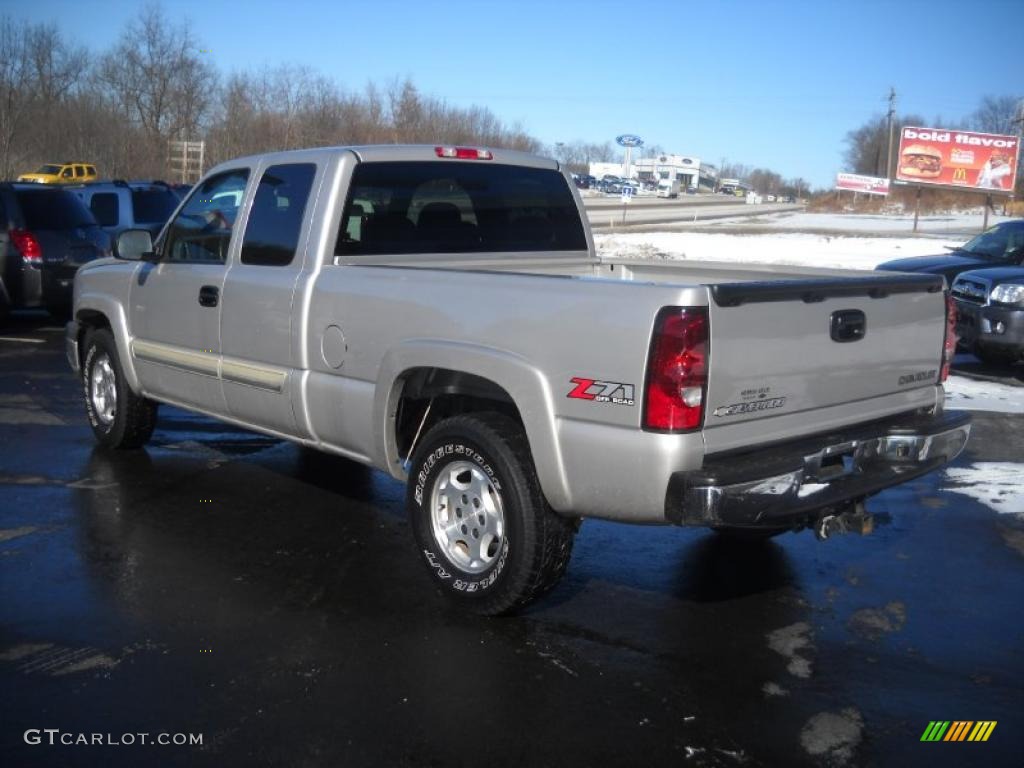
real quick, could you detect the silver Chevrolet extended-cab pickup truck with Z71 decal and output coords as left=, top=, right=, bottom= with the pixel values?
left=67, top=146, right=970, bottom=613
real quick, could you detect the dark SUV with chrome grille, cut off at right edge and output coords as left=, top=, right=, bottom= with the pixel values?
left=950, top=266, right=1024, bottom=364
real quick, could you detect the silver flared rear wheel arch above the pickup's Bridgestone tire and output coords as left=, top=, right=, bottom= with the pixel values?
left=374, top=340, right=571, bottom=511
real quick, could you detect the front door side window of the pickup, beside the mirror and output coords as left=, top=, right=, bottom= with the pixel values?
left=161, top=168, right=249, bottom=264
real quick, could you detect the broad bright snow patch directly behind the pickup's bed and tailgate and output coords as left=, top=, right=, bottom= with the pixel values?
left=594, top=231, right=963, bottom=269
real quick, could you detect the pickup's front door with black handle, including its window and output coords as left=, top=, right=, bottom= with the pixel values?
left=129, top=168, right=249, bottom=414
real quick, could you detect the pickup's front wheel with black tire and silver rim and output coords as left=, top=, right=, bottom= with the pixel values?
left=82, top=329, right=157, bottom=449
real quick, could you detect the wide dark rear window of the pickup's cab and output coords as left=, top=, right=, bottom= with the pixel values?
left=335, top=162, right=587, bottom=256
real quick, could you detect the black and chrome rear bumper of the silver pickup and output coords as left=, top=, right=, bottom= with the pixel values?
left=666, top=412, right=971, bottom=527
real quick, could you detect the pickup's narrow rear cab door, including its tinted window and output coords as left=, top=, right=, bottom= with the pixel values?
left=221, top=163, right=318, bottom=435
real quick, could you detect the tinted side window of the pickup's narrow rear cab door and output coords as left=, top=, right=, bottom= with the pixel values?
left=242, top=163, right=316, bottom=266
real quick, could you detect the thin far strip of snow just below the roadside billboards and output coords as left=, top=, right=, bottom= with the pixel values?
left=712, top=209, right=1012, bottom=236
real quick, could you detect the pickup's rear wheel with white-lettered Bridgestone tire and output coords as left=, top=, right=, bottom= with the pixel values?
left=406, top=413, right=575, bottom=615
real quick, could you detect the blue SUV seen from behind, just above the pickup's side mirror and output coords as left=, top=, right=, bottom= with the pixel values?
left=74, top=179, right=181, bottom=238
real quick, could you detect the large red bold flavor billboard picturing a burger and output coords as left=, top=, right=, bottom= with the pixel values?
left=896, top=127, right=1020, bottom=195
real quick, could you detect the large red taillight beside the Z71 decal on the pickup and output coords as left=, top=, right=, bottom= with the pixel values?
left=643, top=307, right=709, bottom=432
